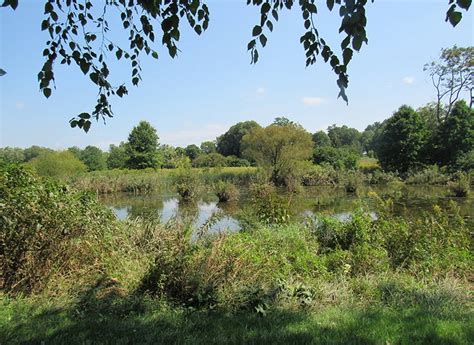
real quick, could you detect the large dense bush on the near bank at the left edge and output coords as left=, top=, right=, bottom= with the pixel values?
left=0, top=167, right=116, bottom=293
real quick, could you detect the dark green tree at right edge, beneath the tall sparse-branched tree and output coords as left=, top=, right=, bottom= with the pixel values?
left=434, top=101, right=474, bottom=166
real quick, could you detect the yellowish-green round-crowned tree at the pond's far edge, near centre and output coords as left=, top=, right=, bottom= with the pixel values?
left=242, top=124, right=313, bottom=185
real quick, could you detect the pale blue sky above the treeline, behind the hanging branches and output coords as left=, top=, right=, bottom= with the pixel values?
left=0, top=0, right=474, bottom=149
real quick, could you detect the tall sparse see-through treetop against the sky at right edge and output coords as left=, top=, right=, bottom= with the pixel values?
left=424, top=46, right=474, bottom=122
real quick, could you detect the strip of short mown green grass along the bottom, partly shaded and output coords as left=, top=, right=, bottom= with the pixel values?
left=0, top=296, right=474, bottom=344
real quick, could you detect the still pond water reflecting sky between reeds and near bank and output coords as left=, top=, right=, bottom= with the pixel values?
left=101, top=186, right=474, bottom=232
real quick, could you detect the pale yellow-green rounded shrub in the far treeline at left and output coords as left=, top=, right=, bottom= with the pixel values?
left=26, top=151, right=87, bottom=179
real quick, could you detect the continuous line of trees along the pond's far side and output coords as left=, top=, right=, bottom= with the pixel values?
left=0, top=101, right=474, bottom=182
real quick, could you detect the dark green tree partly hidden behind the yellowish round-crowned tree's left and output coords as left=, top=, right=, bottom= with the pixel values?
left=217, top=121, right=261, bottom=158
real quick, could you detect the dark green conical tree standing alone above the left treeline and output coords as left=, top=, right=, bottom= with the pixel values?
left=126, top=121, right=158, bottom=169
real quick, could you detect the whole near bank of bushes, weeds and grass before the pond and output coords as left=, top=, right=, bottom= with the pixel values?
left=0, top=168, right=473, bottom=344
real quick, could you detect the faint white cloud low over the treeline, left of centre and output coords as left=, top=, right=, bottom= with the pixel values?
left=160, top=123, right=229, bottom=146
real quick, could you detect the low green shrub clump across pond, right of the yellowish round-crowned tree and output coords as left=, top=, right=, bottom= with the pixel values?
left=313, top=146, right=360, bottom=170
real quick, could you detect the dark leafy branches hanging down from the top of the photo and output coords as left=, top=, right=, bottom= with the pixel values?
left=0, top=0, right=471, bottom=132
